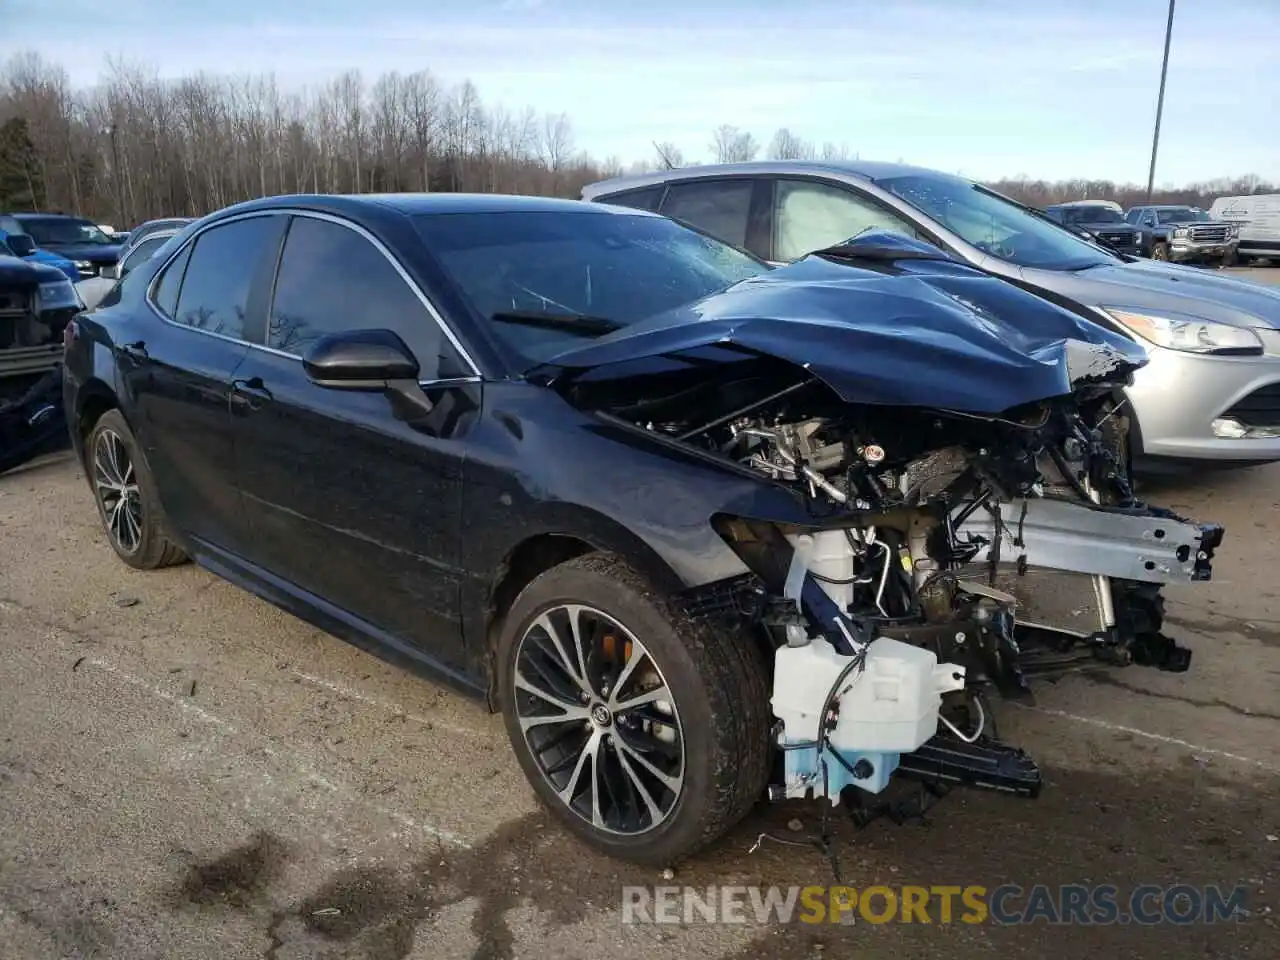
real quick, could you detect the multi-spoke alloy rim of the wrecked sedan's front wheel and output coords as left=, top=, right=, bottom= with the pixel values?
left=513, top=604, right=685, bottom=836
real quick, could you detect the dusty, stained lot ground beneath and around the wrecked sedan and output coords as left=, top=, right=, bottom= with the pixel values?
left=0, top=269, right=1280, bottom=960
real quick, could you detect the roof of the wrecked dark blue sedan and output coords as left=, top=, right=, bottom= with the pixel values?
left=207, top=193, right=654, bottom=216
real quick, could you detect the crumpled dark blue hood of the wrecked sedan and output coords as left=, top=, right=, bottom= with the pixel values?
left=529, top=233, right=1147, bottom=413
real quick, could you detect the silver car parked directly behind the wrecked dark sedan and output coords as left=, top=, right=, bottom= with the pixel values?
left=582, top=160, right=1280, bottom=463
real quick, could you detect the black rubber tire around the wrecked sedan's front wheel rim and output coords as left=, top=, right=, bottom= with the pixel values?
left=495, top=553, right=772, bottom=867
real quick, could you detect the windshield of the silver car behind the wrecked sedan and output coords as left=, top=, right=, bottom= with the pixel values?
left=877, top=174, right=1119, bottom=270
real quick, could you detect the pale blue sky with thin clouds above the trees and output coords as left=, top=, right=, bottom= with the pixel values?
left=0, top=0, right=1280, bottom=183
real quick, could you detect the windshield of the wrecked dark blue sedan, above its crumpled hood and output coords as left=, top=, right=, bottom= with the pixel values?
left=415, top=211, right=769, bottom=369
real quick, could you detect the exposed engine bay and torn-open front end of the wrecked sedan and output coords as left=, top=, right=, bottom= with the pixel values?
left=572, top=358, right=1222, bottom=803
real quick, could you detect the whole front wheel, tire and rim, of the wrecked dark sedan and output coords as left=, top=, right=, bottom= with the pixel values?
left=497, top=554, right=771, bottom=865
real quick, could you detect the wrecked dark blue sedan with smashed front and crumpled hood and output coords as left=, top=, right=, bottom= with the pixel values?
left=64, top=195, right=1222, bottom=864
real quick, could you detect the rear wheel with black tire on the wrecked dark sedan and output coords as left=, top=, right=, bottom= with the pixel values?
left=84, top=410, right=187, bottom=570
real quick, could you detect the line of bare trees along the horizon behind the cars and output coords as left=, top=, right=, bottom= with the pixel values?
left=0, top=52, right=1276, bottom=228
